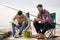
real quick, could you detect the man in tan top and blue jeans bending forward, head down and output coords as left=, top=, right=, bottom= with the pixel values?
left=12, top=11, right=30, bottom=37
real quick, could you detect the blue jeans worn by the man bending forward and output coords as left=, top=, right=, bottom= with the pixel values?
left=12, top=21, right=27, bottom=36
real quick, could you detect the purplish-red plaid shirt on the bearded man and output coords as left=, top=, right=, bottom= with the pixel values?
left=37, top=9, right=51, bottom=23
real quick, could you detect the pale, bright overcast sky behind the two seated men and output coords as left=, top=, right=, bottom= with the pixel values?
left=0, top=0, right=60, bottom=28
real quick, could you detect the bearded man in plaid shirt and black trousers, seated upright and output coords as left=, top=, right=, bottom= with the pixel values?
left=34, top=4, right=51, bottom=38
